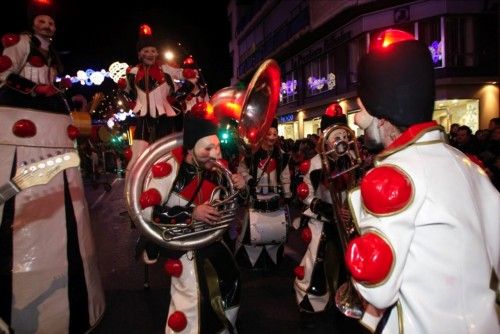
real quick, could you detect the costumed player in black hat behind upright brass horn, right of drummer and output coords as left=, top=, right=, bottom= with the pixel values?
left=294, top=103, right=347, bottom=325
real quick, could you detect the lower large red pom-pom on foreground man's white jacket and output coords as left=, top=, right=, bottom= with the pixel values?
left=345, top=233, right=394, bottom=284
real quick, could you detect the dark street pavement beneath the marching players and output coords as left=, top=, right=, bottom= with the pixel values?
left=85, top=177, right=367, bottom=334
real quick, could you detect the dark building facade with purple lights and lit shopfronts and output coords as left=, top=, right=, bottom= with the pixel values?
left=228, top=0, right=500, bottom=139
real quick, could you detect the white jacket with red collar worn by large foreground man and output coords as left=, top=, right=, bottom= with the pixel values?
left=350, top=122, right=500, bottom=334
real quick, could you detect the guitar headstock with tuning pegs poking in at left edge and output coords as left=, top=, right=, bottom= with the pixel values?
left=0, top=151, right=80, bottom=205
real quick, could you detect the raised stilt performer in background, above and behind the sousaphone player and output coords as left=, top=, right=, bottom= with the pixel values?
left=118, top=24, right=208, bottom=170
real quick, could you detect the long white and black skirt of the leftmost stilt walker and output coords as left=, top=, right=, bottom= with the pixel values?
left=0, top=106, right=104, bottom=333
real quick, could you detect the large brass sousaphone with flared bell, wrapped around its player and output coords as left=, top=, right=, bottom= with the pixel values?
left=125, top=60, right=280, bottom=250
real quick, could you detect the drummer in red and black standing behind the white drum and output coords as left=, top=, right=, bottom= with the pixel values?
left=236, top=119, right=292, bottom=268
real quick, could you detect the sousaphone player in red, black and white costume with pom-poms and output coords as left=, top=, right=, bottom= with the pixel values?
left=140, top=108, right=245, bottom=334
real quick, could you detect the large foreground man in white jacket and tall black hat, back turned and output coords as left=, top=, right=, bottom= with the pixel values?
left=346, top=30, right=500, bottom=334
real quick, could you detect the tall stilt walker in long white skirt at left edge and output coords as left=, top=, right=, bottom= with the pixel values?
left=0, top=2, right=104, bottom=333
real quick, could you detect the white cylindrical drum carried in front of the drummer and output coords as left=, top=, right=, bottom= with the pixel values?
left=248, top=207, right=290, bottom=246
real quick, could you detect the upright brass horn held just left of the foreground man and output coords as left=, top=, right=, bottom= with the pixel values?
left=320, top=124, right=364, bottom=319
